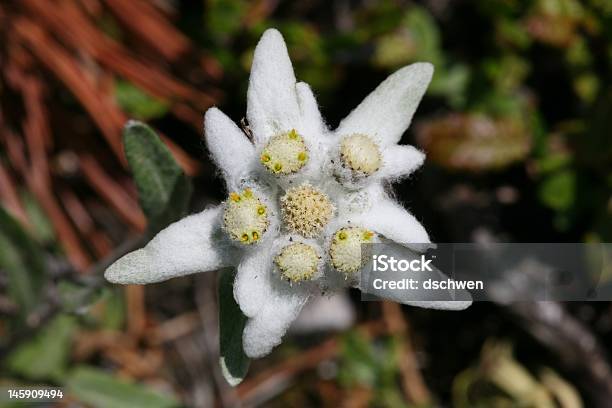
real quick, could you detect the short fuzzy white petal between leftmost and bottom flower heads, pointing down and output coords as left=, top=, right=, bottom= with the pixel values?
left=234, top=247, right=273, bottom=317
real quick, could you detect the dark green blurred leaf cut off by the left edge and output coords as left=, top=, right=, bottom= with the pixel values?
left=0, top=207, right=46, bottom=315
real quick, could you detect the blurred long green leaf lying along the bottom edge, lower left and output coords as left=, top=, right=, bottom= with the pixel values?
left=65, top=366, right=179, bottom=408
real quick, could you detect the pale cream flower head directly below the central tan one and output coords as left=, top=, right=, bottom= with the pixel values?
left=274, top=243, right=321, bottom=283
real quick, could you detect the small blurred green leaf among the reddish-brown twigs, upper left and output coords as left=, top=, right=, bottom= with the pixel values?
left=115, top=80, right=170, bottom=120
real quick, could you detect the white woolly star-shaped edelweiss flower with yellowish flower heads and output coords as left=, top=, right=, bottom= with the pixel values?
left=105, top=30, right=469, bottom=357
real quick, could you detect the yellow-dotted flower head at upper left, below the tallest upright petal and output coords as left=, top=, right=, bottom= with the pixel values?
left=259, top=129, right=308, bottom=174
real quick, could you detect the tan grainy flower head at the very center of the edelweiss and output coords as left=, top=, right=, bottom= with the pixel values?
left=280, top=183, right=334, bottom=238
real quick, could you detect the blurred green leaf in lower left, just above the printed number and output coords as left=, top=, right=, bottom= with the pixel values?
left=7, top=315, right=76, bottom=381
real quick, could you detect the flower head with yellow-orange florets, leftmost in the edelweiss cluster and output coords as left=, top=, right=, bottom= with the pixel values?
left=223, top=188, right=269, bottom=245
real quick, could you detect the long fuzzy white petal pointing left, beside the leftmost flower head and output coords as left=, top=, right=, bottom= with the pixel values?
left=104, top=207, right=230, bottom=284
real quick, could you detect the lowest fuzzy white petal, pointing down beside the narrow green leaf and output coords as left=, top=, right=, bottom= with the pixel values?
left=242, top=285, right=310, bottom=358
